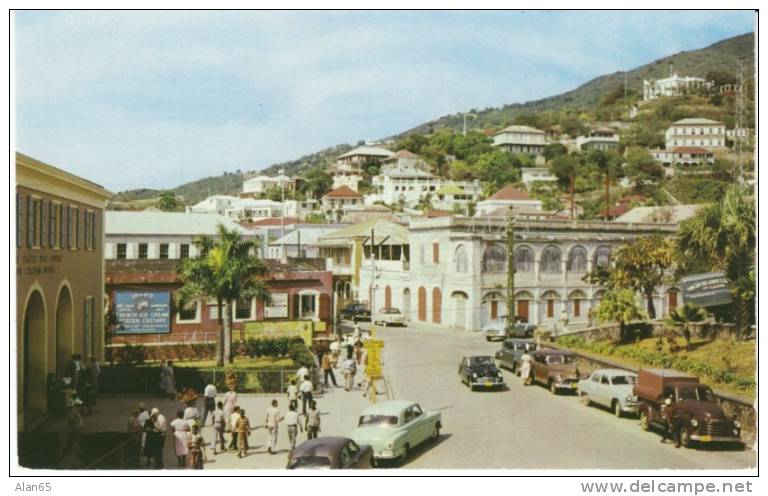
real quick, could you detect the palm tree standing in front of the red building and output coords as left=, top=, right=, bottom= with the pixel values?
left=176, top=224, right=271, bottom=367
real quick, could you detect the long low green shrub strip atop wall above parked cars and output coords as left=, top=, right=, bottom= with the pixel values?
left=558, top=336, right=756, bottom=390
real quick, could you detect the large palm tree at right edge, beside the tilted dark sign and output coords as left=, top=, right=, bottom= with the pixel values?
left=677, top=188, right=756, bottom=340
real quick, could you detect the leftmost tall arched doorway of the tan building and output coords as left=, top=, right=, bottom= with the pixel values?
left=21, top=290, right=48, bottom=412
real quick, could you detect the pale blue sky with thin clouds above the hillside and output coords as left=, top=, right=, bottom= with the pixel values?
left=13, top=11, right=754, bottom=192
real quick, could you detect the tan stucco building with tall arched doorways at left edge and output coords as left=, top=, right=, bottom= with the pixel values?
left=15, top=152, right=112, bottom=431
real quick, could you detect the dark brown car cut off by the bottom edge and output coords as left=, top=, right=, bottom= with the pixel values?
left=288, top=436, right=373, bottom=469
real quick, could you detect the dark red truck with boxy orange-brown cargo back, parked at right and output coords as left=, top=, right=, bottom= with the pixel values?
left=634, top=369, right=741, bottom=448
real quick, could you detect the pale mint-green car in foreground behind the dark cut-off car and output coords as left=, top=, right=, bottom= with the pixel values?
left=349, top=400, right=442, bottom=463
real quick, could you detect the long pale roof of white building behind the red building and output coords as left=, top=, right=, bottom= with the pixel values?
left=104, top=210, right=247, bottom=236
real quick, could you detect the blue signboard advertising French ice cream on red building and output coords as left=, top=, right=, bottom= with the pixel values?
left=115, top=291, right=171, bottom=334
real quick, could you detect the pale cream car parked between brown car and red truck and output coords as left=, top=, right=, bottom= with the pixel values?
left=579, top=369, right=637, bottom=417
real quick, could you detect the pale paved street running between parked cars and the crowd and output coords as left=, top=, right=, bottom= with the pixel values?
left=370, top=322, right=755, bottom=469
